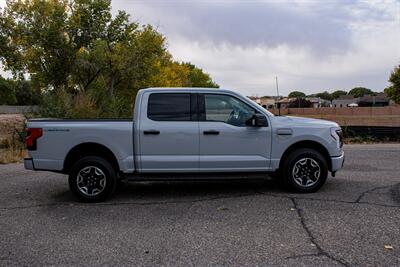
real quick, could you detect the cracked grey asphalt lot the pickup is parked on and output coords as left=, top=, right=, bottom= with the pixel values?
left=0, top=144, right=400, bottom=266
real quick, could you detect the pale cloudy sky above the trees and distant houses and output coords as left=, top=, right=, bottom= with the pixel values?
left=0, top=0, right=400, bottom=96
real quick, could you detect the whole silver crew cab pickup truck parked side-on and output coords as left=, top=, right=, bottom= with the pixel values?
left=24, top=88, right=344, bottom=202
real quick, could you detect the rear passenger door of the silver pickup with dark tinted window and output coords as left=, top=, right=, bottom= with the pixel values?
left=139, top=92, right=199, bottom=172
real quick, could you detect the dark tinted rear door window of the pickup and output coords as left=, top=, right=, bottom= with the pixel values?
left=147, top=93, right=190, bottom=121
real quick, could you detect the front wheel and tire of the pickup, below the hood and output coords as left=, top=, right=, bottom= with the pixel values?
left=282, top=148, right=328, bottom=193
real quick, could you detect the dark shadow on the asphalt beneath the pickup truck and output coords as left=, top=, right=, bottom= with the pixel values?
left=52, top=179, right=350, bottom=203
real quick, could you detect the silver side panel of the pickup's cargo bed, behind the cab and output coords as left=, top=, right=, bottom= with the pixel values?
left=27, top=119, right=135, bottom=173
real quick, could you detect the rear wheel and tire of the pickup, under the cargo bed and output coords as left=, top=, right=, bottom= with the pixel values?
left=68, top=156, right=117, bottom=202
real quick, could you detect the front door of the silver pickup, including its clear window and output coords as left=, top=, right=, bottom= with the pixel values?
left=199, top=93, right=271, bottom=172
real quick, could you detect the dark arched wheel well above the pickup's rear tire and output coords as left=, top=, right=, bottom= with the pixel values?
left=63, top=142, right=120, bottom=173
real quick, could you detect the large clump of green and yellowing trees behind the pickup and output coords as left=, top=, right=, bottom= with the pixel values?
left=0, top=0, right=218, bottom=116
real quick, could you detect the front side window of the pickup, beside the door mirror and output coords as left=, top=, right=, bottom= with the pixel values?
left=204, top=94, right=256, bottom=127
